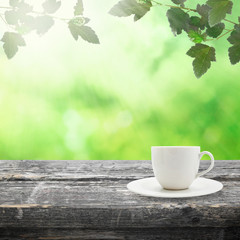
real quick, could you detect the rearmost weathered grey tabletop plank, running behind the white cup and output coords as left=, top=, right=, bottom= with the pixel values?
left=0, top=160, right=240, bottom=181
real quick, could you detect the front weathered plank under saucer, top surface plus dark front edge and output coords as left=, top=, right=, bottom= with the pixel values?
left=0, top=180, right=240, bottom=228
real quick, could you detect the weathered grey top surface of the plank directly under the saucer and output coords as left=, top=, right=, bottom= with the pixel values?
left=0, top=180, right=240, bottom=208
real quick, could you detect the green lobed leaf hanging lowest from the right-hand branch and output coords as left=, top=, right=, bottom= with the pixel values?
left=187, top=43, right=216, bottom=78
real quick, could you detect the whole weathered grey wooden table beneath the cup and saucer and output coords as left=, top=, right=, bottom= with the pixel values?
left=0, top=160, right=240, bottom=240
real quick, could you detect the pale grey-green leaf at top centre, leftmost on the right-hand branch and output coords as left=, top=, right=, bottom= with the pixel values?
left=109, top=0, right=152, bottom=21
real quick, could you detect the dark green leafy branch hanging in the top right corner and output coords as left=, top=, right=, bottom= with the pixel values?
left=109, top=0, right=240, bottom=78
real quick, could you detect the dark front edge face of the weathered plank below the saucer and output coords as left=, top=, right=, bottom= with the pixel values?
left=0, top=206, right=240, bottom=230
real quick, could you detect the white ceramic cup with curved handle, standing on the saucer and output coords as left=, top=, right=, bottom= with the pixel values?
left=151, top=146, right=214, bottom=190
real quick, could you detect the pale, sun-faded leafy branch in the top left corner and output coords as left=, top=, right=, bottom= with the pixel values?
left=0, top=0, right=99, bottom=59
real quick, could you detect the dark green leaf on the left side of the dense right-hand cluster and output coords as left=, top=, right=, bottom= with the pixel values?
left=167, top=8, right=189, bottom=35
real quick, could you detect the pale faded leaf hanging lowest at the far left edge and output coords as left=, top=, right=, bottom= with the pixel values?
left=1, top=32, right=26, bottom=59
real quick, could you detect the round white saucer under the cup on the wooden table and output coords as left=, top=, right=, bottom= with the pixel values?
left=127, top=177, right=223, bottom=198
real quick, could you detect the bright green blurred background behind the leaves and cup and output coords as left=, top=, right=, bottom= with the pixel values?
left=0, top=0, right=240, bottom=160
